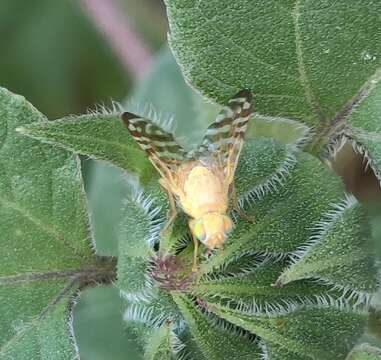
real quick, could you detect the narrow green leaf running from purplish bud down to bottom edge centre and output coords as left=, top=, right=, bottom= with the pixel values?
left=173, top=294, right=262, bottom=360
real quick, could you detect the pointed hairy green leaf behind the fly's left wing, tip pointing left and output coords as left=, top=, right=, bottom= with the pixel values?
left=17, top=113, right=153, bottom=181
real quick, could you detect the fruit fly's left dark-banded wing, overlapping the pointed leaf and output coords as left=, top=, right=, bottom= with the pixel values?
left=122, top=112, right=186, bottom=178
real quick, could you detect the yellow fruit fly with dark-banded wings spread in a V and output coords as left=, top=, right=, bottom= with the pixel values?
left=122, top=90, right=252, bottom=271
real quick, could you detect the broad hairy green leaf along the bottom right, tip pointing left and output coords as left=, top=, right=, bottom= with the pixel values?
left=208, top=304, right=365, bottom=360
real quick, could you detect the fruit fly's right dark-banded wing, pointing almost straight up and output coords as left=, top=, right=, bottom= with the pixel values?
left=198, top=89, right=252, bottom=184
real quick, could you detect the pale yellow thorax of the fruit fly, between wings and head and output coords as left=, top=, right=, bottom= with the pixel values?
left=179, top=165, right=228, bottom=219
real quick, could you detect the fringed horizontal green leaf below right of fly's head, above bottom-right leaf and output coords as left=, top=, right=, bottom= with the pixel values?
left=190, top=256, right=338, bottom=312
